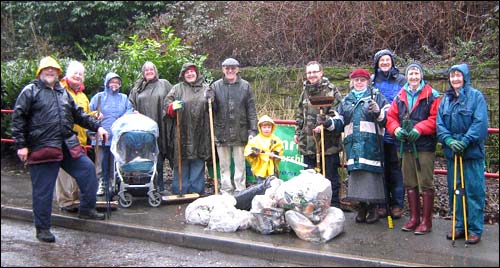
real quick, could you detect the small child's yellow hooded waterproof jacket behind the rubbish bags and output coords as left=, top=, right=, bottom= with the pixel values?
left=244, top=115, right=283, bottom=178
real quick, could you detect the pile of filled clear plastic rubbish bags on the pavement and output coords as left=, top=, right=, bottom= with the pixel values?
left=185, top=170, right=345, bottom=242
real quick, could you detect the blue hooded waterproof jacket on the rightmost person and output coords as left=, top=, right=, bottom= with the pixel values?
left=436, top=64, right=488, bottom=159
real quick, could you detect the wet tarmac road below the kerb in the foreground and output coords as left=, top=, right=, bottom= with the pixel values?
left=1, top=218, right=297, bottom=267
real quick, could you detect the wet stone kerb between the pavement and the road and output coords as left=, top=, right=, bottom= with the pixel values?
left=1, top=205, right=429, bottom=267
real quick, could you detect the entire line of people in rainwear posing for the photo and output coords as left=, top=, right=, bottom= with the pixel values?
left=12, top=49, right=488, bottom=244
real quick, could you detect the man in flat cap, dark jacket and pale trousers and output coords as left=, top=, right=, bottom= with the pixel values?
left=205, top=58, right=257, bottom=194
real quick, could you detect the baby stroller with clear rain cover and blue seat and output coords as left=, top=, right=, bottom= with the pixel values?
left=111, top=113, right=162, bottom=208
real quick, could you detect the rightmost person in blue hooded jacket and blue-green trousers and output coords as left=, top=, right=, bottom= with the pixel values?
left=436, top=64, right=488, bottom=244
